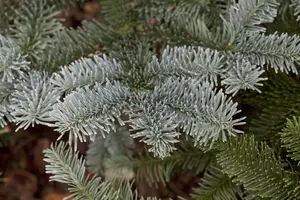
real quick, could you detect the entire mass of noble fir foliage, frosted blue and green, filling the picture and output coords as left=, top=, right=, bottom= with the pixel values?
left=0, top=0, right=300, bottom=200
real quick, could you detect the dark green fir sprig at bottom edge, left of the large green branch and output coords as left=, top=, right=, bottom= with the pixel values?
left=191, top=165, right=243, bottom=200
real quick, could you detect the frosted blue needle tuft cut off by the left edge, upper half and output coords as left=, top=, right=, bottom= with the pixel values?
left=0, top=35, right=29, bottom=82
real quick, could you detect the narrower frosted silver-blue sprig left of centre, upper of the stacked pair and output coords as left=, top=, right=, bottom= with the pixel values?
left=51, top=55, right=122, bottom=92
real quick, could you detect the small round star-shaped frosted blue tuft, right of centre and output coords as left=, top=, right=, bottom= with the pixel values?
left=221, top=59, right=267, bottom=96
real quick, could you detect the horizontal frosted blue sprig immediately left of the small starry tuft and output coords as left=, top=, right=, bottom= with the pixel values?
left=151, top=46, right=225, bottom=84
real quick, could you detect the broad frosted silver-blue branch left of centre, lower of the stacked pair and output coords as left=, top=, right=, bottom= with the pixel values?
left=50, top=81, right=131, bottom=144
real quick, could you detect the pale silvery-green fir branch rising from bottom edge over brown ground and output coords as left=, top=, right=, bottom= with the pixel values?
left=44, top=142, right=121, bottom=200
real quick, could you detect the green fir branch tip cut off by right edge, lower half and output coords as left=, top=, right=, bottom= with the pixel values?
left=280, top=117, right=300, bottom=165
